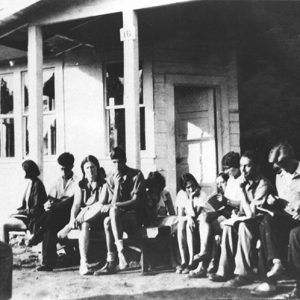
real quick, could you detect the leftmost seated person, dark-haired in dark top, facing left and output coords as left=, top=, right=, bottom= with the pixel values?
left=0, top=160, right=47, bottom=243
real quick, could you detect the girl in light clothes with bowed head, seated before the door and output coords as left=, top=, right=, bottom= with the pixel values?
left=176, top=173, right=208, bottom=274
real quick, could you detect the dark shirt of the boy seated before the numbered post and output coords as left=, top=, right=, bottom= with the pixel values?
left=107, top=167, right=146, bottom=209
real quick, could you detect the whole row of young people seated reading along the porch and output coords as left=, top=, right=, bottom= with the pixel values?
left=0, top=143, right=300, bottom=298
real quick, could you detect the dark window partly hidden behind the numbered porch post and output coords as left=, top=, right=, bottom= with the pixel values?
left=105, top=63, right=146, bottom=151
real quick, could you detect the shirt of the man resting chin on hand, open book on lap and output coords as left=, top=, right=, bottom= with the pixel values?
left=240, top=175, right=274, bottom=213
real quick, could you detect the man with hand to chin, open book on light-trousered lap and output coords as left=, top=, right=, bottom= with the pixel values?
left=210, top=151, right=273, bottom=287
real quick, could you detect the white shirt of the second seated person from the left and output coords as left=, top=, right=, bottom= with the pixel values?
left=49, top=174, right=78, bottom=200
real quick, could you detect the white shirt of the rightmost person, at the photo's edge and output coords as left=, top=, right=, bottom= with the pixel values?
left=276, top=163, right=300, bottom=214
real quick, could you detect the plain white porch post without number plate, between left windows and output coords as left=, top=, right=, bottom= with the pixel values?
left=27, top=26, right=43, bottom=174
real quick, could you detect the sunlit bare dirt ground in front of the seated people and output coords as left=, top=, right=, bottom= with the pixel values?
left=12, top=236, right=294, bottom=300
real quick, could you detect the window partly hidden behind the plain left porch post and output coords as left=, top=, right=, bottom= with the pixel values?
left=22, top=68, right=56, bottom=156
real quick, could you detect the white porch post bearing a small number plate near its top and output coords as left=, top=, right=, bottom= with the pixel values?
left=120, top=9, right=141, bottom=168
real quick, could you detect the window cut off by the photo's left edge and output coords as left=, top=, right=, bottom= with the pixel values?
left=0, top=74, right=15, bottom=157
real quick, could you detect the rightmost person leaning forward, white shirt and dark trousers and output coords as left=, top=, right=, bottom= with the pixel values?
left=251, top=142, right=300, bottom=298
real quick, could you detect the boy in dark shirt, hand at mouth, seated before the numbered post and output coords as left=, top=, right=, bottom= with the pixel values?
left=94, top=147, right=146, bottom=275
